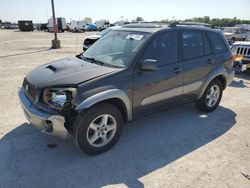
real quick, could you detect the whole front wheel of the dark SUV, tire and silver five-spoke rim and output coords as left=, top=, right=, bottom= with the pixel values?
left=73, top=103, right=123, bottom=155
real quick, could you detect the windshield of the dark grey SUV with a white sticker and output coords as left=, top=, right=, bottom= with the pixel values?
left=83, top=31, right=147, bottom=68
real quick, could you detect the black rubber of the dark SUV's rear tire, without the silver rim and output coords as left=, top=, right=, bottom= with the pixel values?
left=195, top=79, right=223, bottom=112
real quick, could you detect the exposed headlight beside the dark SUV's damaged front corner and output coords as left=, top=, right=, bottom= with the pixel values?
left=43, top=88, right=76, bottom=110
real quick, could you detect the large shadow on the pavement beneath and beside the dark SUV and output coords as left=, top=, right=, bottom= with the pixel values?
left=0, top=104, right=236, bottom=188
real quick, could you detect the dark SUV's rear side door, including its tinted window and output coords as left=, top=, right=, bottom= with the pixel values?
left=181, top=29, right=217, bottom=98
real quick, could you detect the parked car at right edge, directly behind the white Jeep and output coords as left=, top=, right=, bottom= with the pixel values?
left=223, top=27, right=250, bottom=43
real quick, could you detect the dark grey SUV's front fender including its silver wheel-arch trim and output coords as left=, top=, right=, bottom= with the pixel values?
left=73, top=69, right=132, bottom=120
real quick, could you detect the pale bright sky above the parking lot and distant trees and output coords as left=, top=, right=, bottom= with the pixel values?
left=0, top=0, right=250, bottom=22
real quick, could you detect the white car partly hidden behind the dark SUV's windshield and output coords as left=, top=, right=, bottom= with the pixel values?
left=83, top=26, right=120, bottom=51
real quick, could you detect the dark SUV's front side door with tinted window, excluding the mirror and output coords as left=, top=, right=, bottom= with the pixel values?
left=133, top=31, right=183, bottom=116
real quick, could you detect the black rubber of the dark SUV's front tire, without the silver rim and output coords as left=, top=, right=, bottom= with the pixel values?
left=72, top=103, right=123, bottom=155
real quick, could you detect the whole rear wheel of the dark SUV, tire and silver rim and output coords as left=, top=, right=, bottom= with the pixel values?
left=196, top=79, right=223, bottom=112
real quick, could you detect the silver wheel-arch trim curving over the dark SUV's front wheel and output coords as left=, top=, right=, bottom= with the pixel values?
left=76, top=89, right=132, bottom=121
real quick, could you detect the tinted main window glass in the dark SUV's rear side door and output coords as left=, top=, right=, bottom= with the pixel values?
left=182, top=31, right=204, bottom=60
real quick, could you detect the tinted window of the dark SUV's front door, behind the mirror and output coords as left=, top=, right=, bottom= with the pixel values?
left=143, top=32, right=178, bottom=65
